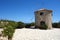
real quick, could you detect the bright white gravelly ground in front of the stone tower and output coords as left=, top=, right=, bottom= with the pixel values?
left=12, top=28, right=60, bottom=40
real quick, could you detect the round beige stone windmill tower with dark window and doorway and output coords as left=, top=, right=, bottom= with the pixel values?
left=34, top=9, right=52, bottom=29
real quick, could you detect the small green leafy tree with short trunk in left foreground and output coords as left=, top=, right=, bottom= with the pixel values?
left=2, top=26, right=15, bottom=40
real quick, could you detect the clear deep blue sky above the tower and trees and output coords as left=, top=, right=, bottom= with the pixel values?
left=0, top=0, right=60, bottom=23
